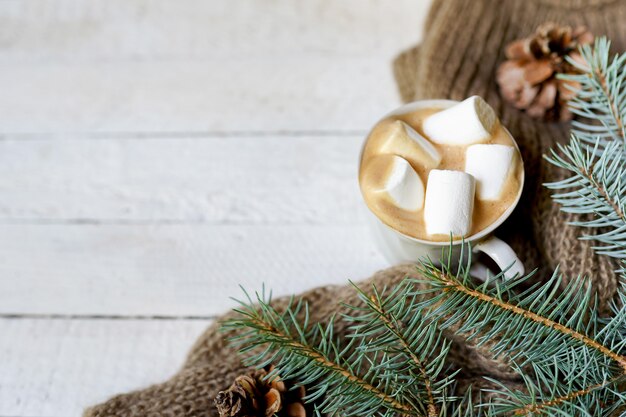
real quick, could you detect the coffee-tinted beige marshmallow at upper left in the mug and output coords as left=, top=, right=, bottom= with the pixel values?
left=380, top=120, right=441, bottom=169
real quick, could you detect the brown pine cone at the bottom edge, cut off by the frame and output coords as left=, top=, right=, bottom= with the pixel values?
left=215, top=366, right=307, bottom=417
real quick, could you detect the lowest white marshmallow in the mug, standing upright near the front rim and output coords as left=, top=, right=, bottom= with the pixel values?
left=424, top=169, right=475, bottom=236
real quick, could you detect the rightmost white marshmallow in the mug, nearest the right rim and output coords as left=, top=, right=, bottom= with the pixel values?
left=465, top=145, right=515, bottom=200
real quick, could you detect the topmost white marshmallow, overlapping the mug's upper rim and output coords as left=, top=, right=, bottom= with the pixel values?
left=423, top=96, right=498, bottom=145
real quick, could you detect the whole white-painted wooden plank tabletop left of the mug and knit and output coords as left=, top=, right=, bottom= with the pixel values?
left=0, top=0, right=428, bottom=417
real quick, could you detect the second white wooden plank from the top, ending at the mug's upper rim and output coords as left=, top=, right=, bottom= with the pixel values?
left=0, top=57, right=398, bottom=133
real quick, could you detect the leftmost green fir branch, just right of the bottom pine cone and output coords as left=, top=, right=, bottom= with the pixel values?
left=224, top=294, right=424, bottom=417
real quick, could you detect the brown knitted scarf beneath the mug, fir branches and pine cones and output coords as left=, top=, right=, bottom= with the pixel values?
left=85, top=0, right=626, bottom=417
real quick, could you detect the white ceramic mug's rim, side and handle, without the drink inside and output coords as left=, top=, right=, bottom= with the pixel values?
left=359, top=100, right=524, bottom=279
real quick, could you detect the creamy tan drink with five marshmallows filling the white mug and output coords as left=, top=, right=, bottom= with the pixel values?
left=359, top=96, right=523, bottom=241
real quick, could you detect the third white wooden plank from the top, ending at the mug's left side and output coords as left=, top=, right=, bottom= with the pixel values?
left=0, top=135, right=363, bottom=225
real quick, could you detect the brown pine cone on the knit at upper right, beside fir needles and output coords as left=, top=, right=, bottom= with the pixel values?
left=496, top=23, right=594, bottom=121
